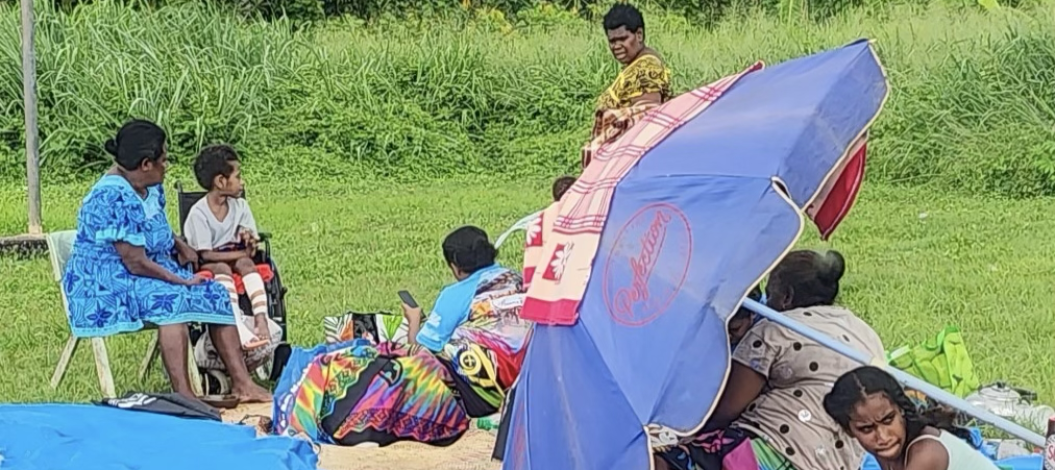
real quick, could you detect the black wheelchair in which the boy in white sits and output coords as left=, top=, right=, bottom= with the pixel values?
left=176, top=182, right=288, bottom=344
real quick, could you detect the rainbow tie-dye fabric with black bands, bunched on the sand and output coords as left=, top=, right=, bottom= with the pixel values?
left=274, top=339, right=468, bottom=446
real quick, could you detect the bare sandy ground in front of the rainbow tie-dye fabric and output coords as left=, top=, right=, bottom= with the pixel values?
left=224, top=403, right=502, bottom=470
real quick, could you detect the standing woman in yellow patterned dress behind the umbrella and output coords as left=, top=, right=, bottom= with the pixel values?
left=582, top=3, right=671, bottom=168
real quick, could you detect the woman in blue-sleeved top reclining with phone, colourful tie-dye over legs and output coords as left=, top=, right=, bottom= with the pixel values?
left=275, top=227, right=530, bottom=446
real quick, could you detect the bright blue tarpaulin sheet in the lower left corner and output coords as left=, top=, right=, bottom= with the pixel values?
left=0, top=405, right=319, bottom=470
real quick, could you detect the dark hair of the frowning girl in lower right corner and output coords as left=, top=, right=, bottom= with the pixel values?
left=824, top=365, right=972, bottom=443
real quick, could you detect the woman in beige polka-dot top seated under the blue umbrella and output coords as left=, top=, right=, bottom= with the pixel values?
left=656, top=250, right=883, bottom=470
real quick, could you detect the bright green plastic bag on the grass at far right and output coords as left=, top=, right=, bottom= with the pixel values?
left=887, top=326, right=980, bottom=398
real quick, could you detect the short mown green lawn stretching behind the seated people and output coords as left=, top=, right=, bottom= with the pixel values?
left=0, top=180, right=1055, bottom=402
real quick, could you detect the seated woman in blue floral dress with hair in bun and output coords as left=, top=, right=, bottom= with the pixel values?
left=62, top=120, right=271, bottom=401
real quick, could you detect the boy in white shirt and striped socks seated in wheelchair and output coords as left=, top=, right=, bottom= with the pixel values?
left=184, top=145, right=282, bottom=354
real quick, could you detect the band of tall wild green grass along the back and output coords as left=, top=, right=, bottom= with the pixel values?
left=0, top=0, right=1055, bottom=196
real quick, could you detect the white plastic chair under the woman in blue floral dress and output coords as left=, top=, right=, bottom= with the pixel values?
left=46, top=230, right=202, bottom=398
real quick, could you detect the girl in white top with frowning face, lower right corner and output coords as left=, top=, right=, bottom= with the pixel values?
left=824, top=365, right=997, bottom=470
